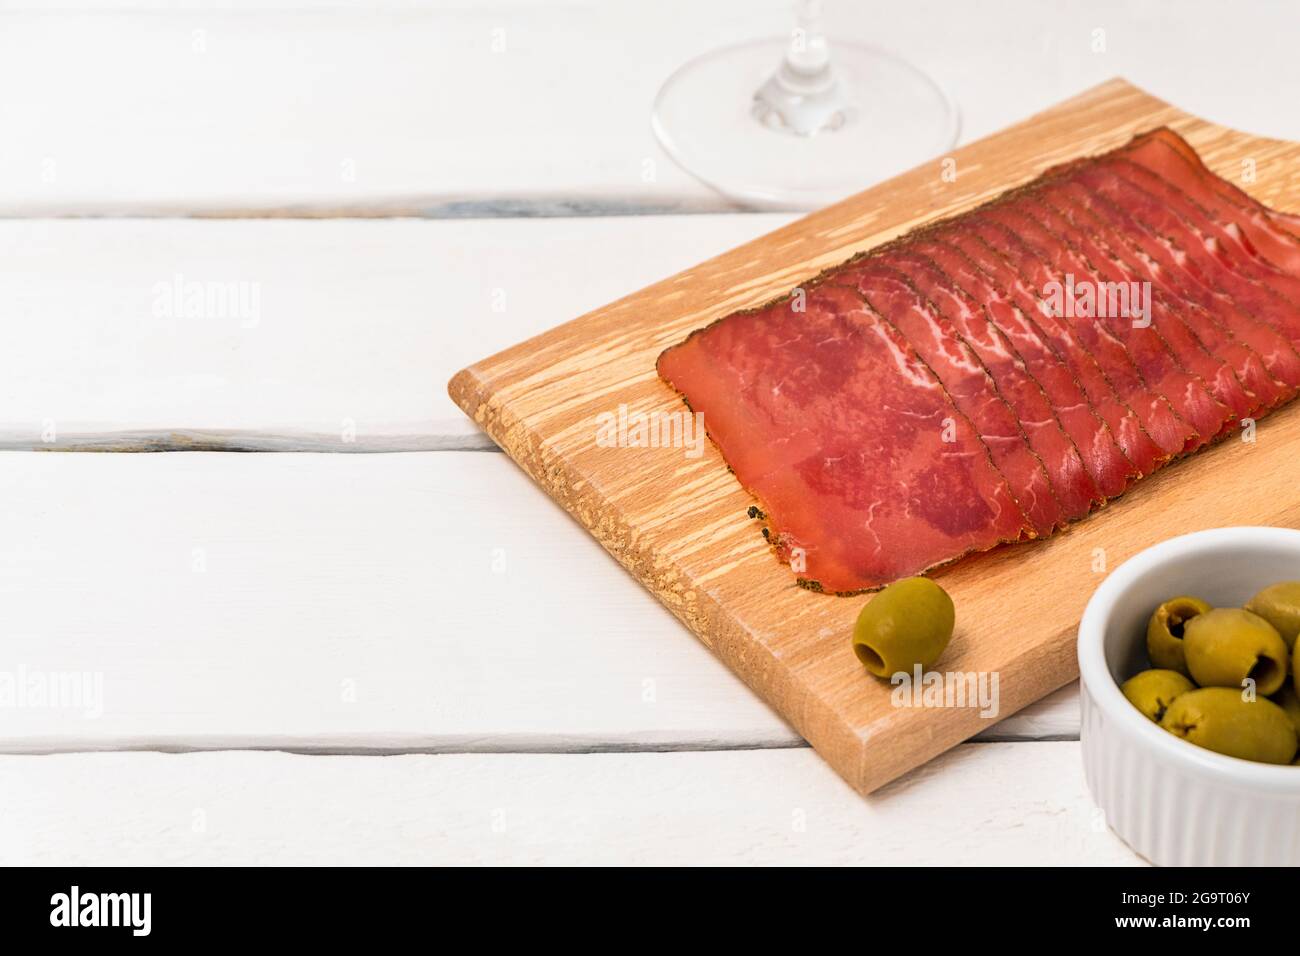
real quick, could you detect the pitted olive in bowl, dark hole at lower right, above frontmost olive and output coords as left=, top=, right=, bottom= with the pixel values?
left=1183, top=607, right=1287, bottom=697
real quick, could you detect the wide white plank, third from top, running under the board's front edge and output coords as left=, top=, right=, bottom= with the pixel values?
left=0, top=453, right=1078, bottom=752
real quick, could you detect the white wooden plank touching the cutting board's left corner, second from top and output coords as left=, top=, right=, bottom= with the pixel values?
left=0, top=214, right=792, bottom=451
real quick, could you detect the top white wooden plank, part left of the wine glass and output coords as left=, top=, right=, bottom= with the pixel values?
left=0, top=1, right=769, bottom=215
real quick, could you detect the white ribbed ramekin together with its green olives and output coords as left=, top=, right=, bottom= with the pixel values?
left=1079, top=528, right=1300, bottom=866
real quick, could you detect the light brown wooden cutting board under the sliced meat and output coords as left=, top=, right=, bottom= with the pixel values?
left=450, top=79, right=1300, bottom=793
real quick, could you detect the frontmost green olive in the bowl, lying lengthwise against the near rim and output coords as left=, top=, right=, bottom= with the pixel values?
left=1160, top=686, right=1296, bottom=763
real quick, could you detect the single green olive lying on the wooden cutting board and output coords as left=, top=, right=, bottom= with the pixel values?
left=853, top=578, right=956, bottom=678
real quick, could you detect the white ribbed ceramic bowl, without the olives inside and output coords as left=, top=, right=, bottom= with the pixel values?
left=1079, top=528, right=1300, bottom=866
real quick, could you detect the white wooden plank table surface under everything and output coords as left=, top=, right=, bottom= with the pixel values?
left=0, top=0, right=1300, bottom=864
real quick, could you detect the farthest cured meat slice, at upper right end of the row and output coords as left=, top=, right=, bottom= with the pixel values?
left=1117, top=127, right=1300, bottom=274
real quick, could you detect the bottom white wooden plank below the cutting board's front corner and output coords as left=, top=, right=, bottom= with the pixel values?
left=0, top=743, right=1141, bottom=866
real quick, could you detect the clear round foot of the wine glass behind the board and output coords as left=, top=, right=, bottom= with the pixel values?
left=653, top=38, right=959, bottom=209
